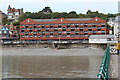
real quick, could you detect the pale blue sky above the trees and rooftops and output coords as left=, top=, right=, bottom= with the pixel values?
left=0, top=0, right=119, bottom=14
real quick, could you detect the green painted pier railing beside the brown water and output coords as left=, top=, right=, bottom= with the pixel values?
left=97, top=46, right=110, bottom=80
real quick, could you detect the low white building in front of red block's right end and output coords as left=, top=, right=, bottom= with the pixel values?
left=89, top=35, right=114, bottom=44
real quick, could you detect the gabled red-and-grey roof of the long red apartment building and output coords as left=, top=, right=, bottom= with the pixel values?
left=21, top=17, right=106, bottom=24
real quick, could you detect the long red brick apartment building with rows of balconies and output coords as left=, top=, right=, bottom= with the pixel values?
left=20, top=17, right=107, bottom=42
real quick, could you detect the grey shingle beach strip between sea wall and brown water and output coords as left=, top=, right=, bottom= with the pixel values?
left=1, top=47, right=104, bottom=56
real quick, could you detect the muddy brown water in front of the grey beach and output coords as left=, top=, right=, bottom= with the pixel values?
left=2, top=56, right=102, bottom=78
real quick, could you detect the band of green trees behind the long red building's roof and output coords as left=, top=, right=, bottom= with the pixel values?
left=18, top=7, right=118, bottom=22
